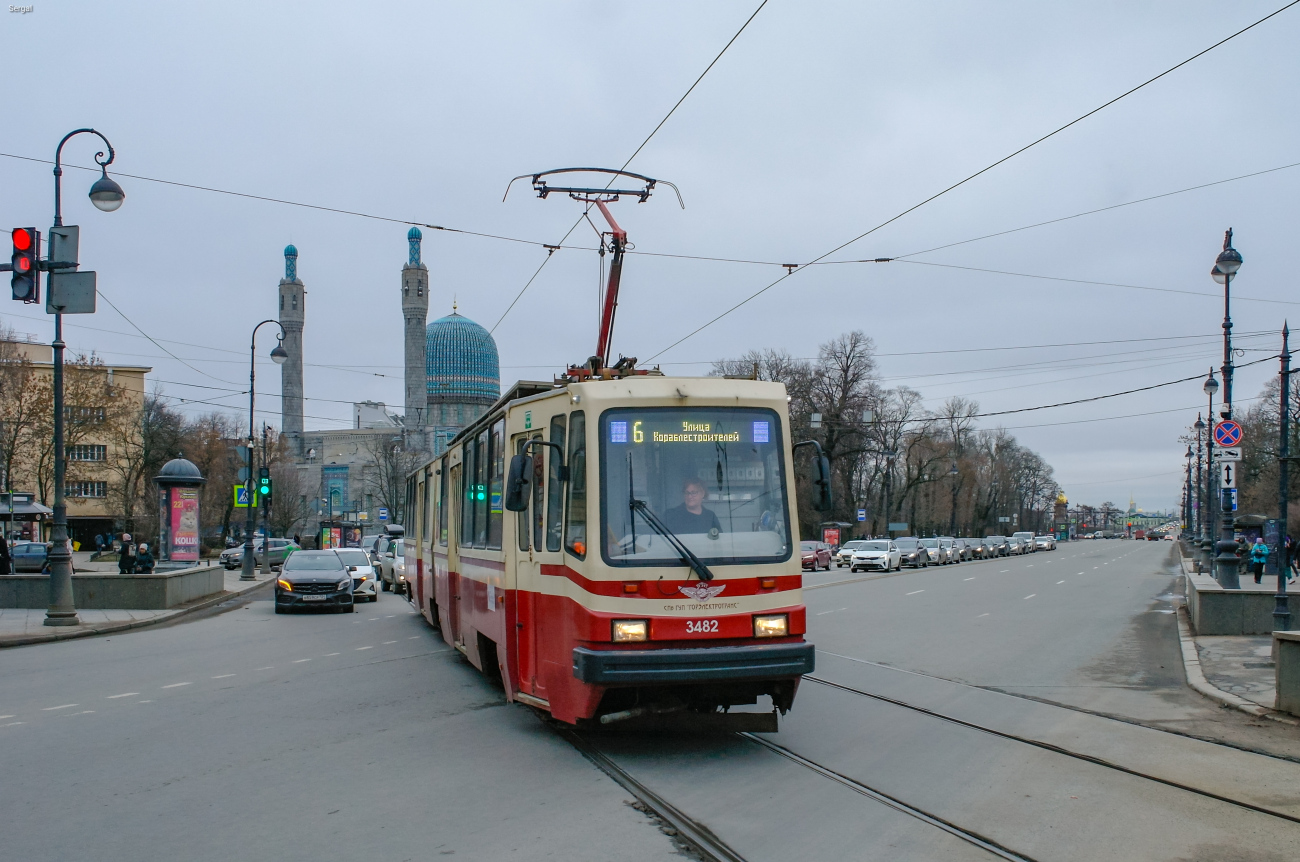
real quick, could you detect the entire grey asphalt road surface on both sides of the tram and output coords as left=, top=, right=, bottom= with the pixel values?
left=0, top=541, right=1300, bottom=862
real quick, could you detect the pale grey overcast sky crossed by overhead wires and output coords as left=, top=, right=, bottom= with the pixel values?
left=0, top=0, right=1300, bottom=510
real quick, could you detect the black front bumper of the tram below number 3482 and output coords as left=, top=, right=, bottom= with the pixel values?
left=573, top=644, right=816, bottom=685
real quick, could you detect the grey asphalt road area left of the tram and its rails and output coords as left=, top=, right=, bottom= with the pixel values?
left=0, top=593, right=681, bottom=862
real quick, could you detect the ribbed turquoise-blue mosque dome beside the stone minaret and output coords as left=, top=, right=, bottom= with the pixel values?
left=424, top=311, right=501, bottom=408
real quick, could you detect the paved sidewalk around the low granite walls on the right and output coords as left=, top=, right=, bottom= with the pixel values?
left=1178, top=548, right=1300, bottom=724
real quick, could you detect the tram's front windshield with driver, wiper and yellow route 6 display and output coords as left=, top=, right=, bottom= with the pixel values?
left=599, top=407, right=790, bottom=566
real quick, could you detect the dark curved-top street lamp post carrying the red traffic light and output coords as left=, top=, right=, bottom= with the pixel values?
left=46, top=129, right=126, bottom=625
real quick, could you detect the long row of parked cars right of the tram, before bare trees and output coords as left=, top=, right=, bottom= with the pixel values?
left=802, top=532, right=1056, bottom=572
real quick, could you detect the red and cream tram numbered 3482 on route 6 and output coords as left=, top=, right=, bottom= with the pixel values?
left=407, top=374, right=814, bottom=729
